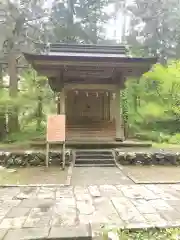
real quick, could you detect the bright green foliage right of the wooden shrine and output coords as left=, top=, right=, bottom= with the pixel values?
left=126, top=61, right=180, bottom=143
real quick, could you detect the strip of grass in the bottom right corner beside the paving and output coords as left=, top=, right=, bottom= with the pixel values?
left=103, top=228, right=180, bottom=240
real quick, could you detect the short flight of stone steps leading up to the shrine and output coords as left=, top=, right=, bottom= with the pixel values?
left=74, top=149, right=115, bottom=167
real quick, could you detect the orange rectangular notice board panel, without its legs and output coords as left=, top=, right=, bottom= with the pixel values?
left=46, top=115, right=65, bottom=143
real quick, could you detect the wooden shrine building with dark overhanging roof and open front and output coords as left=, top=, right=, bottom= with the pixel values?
left=24, top=44, right=156, bottom=142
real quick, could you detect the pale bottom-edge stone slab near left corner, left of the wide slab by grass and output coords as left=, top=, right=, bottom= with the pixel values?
left=3, top=227, right=49, bottom=240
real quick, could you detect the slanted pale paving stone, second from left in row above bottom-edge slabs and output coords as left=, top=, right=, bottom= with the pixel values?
left=24, top=208, right=53, bottom=228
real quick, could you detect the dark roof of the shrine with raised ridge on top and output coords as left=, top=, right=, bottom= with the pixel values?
left=24, top=44, right=157, bottom=64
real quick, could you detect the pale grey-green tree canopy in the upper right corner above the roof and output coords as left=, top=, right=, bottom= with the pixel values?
left=127, top=0, right=180, bottom=62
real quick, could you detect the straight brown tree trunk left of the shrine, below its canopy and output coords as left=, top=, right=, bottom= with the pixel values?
left=8, top=52, right=19, bottom=133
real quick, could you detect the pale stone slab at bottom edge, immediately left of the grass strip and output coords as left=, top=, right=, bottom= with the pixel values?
left=49, top=225, right=92, bottom=240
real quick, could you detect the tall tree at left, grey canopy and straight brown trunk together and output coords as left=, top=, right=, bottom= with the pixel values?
left=1, top=0, right=48, bottom=132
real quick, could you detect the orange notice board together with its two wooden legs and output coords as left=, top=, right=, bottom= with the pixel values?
left=46, top=114, right=65, bottom=169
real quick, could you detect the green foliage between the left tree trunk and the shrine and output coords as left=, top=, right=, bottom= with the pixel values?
left=18, top=71, right=54, bottom=130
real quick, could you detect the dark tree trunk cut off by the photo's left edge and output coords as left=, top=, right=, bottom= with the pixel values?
left=0, top=65, right=7, bottom=140
